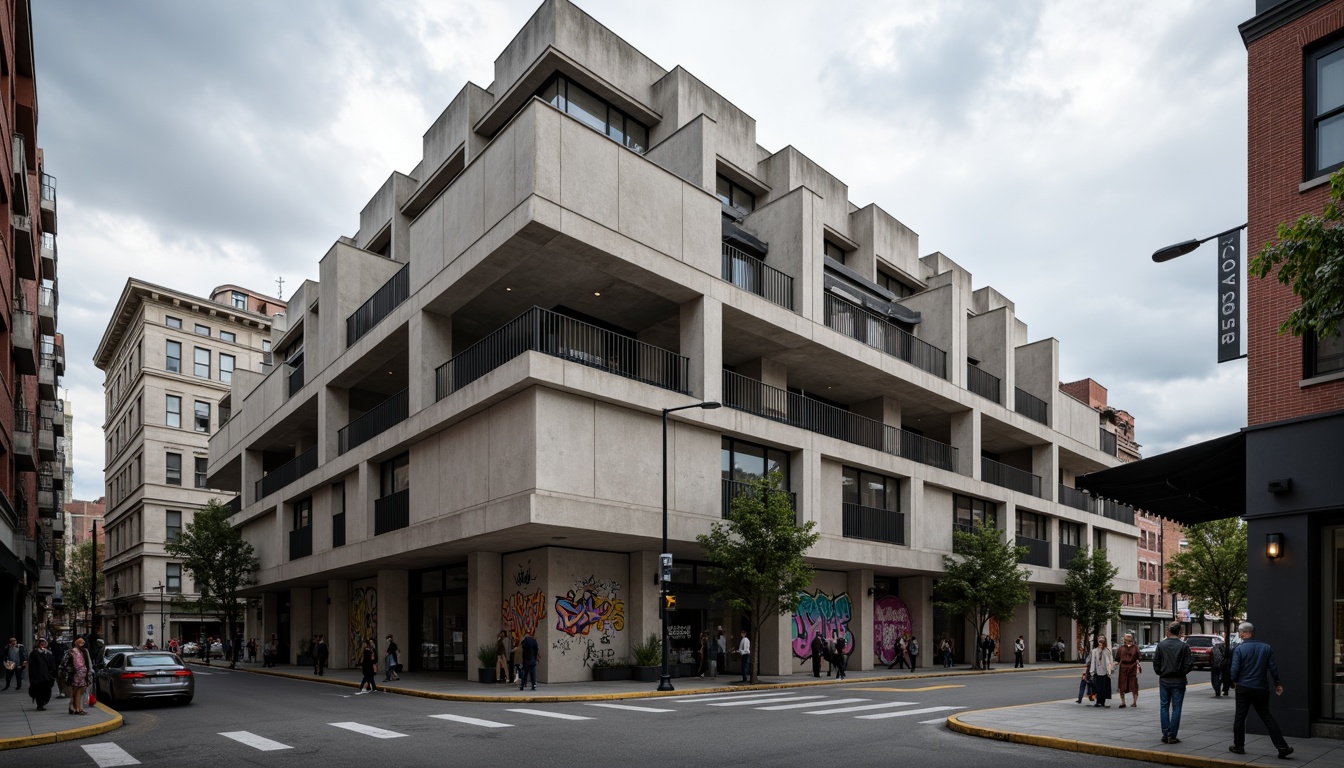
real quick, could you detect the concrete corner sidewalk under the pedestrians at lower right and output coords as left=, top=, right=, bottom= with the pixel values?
left=948, top=685, right=1344, bottom=768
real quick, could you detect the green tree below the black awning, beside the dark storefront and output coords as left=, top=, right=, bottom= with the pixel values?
left=1167, top=518, right=1246, bottom=640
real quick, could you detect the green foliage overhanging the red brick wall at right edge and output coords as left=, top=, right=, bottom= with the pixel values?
left=1250, top=171, right=1344, bottom=339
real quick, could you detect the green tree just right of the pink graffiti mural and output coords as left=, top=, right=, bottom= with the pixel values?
left=934, top=522, right=1031, bottom=670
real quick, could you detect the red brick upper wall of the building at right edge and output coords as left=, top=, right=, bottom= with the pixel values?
left=1246, top=1, right=1344, bottom=425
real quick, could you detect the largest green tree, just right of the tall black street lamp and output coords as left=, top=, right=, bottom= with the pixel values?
left=696, top=472, right=820, bottom=682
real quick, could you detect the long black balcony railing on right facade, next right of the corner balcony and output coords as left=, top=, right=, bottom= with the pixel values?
left=723, top=371, right=957, bottom=472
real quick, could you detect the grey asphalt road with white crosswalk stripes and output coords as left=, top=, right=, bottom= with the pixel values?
left=23, top=668, right=1157, bottom=768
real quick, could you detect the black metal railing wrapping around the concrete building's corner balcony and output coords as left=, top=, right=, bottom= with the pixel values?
left=434, top=307, right=691, bottom=401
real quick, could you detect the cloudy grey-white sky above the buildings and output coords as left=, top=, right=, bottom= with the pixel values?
left=34, top=0, right=1254, bottom=499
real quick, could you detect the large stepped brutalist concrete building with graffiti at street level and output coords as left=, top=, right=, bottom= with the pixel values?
left=210, top=0, right=1138, bottom=682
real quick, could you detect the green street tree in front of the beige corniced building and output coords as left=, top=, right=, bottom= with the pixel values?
left=164, top=499, right=258, bottom=666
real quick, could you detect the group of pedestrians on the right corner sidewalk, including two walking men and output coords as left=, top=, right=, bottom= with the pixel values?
left=1078, top=621, right=1293, bottom=759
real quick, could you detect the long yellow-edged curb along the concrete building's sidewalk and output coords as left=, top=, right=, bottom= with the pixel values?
left=191, top=662, right=1058, bottom=703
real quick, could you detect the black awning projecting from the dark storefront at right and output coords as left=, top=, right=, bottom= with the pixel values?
left=1078, top=432, right=1246, bottom=525
